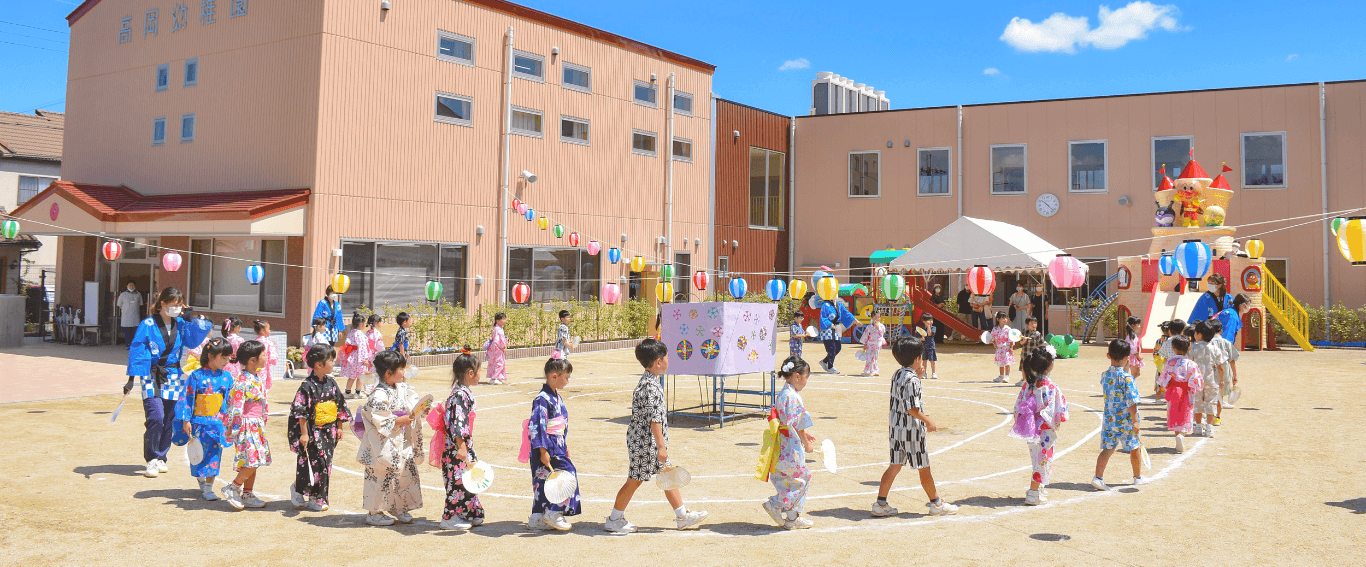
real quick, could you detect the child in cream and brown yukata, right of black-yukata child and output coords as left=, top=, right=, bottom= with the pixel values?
left=355, top=351, right=430, bottom=526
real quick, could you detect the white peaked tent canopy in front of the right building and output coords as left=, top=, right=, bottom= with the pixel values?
left=888, top=217, right=1063, bottom=273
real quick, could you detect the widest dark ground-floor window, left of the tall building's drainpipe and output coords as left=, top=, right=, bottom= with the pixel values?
left=342, top=240, right=469, bottom=314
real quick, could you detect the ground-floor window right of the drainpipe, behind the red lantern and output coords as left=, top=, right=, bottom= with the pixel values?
left=508, top=247, right=601, bottom=302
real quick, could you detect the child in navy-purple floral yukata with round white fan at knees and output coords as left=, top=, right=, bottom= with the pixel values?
left=526, top=358, right=583, bottom=531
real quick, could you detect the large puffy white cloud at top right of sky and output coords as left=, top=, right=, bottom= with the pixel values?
left=1001, top=0, right=1187, bottom=53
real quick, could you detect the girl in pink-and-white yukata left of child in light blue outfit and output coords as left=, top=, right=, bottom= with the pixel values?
left=1009, top=347, right=1067, bottom=506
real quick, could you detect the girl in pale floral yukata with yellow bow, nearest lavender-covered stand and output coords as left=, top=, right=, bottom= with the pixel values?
left=764, top=357, right=816, bottom=530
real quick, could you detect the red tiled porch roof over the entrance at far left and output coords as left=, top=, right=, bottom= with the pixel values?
left=11, top=180, right=310, bottom=223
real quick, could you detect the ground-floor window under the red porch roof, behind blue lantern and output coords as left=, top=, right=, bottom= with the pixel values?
left=190, top=238, right=285, bottom=313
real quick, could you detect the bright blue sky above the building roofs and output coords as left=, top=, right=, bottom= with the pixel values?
left=0, top=0, right=1366, bottom=115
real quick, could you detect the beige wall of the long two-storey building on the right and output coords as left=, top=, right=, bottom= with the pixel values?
left=794, top=82, right=1366, bottom=311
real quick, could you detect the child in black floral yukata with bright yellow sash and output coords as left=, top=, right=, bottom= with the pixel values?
left=287, top=343, right=351, bottom=512
